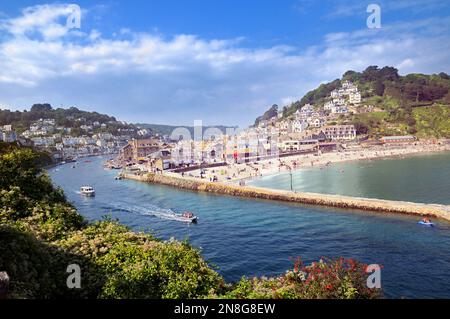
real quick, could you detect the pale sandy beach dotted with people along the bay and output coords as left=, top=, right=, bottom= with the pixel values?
left=175, top=142, right=450, bottom=184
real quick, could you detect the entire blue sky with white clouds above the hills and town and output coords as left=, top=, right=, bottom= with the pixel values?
left=0, top=0, right=450, bottom=126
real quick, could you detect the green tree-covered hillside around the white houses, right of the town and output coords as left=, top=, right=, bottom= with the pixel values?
left=256, top=66, right=450, bottom=137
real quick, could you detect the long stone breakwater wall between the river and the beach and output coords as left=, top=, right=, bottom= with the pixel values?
left=123, top=173, right=450, bottom=221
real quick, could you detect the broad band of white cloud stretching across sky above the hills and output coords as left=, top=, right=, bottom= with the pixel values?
left=0, top=5, right=450, bottom=124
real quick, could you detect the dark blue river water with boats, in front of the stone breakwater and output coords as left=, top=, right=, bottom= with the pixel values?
left=50, top=158, right=450, bottom=298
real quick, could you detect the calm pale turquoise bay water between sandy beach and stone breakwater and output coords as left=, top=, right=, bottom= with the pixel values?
left=250, top=153, right=450, bottom=204
